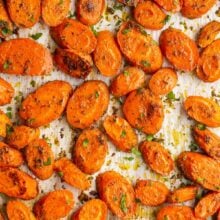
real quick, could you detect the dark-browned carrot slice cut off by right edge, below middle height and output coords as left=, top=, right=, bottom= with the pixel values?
left=193, top=127, right=220, bottom=161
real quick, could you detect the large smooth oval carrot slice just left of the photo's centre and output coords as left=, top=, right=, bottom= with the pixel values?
left=67, top=80, right=109, bottom=129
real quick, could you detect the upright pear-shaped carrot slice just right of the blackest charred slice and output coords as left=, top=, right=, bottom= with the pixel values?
left=94, top=31, right=122, bottom=76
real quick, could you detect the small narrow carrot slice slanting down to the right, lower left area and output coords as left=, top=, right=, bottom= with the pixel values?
left=54, top=157, right=90, bottom=190
